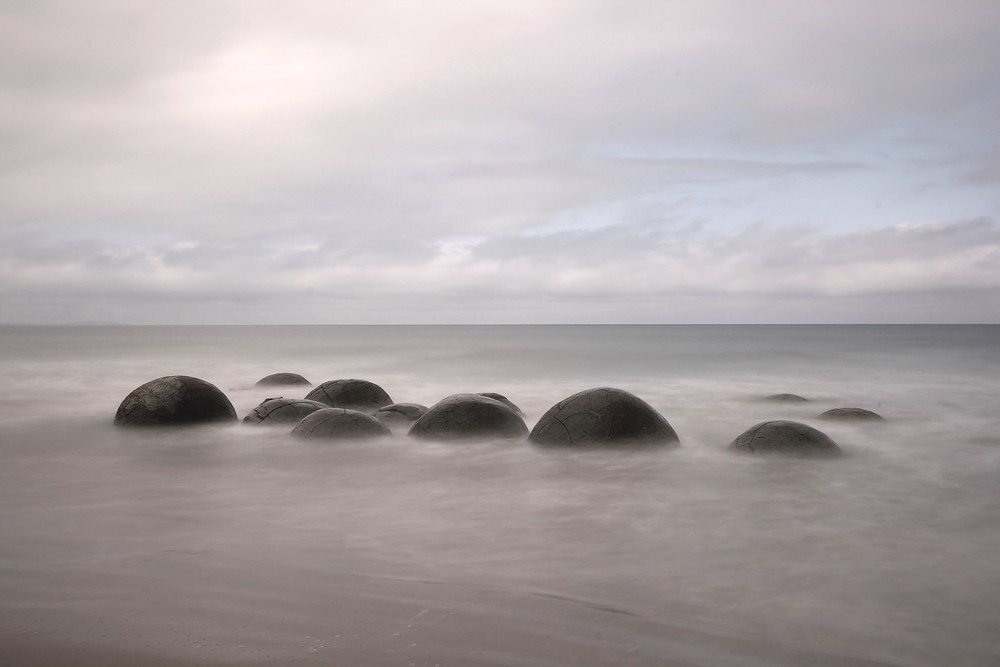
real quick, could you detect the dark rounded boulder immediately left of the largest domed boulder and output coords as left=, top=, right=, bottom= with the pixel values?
left=410, top=394, right=528, bottom=440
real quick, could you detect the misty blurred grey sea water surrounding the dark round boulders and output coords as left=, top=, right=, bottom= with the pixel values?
left=0, top=325, right=1000, bottom=665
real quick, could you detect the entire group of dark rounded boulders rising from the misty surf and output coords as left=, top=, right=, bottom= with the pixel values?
left=114, top=373, right=883, bottom=457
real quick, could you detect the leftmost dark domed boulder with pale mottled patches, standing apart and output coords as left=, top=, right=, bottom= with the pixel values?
left=114, top=375, right=236, bottom=426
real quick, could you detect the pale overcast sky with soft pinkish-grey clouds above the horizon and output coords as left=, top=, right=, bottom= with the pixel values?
left=0, top=0, right=1000, bottom=324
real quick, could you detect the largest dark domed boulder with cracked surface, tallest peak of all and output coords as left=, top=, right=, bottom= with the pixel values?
left=528, top=387, right=678, bottom=447
